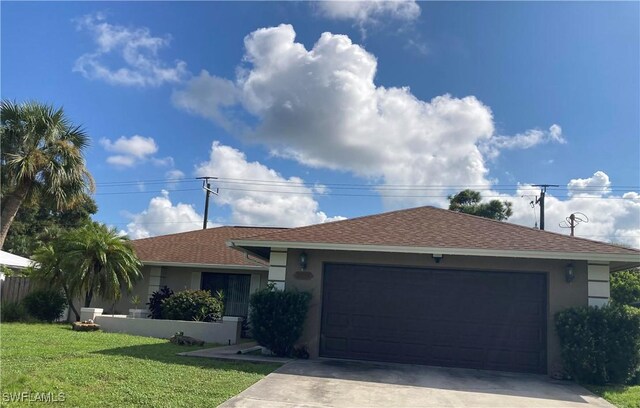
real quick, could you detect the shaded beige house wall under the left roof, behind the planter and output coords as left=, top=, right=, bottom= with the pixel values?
left=90, top=266, right=268, bottom=314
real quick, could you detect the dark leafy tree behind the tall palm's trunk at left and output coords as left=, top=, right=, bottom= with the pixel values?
left=4, top=194, right=98, bottom=258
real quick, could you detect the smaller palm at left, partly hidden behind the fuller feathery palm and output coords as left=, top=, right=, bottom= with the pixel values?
left=29, top=239, right=80, bottom=320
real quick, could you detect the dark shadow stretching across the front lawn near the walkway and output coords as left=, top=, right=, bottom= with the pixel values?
left=92, top=342, right=282, bottom=374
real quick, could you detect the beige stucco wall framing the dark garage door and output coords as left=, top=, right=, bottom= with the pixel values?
left=285, top=249, right=588, bottom=374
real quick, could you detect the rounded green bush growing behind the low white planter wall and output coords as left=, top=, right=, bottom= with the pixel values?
left=162, top=290, right=224, bottom=322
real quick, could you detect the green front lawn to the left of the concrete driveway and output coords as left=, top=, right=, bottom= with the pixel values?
left=0, top=323, right=278, bottom=407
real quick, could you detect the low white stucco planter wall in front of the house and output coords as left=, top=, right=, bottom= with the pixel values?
left=81, top=307, right=242, bottom=345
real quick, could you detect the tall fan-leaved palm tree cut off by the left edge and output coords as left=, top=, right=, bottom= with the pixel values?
left=0, top=100, right=94, bottom=248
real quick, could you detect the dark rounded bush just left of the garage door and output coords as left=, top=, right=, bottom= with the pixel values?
left=249, top=288, right=311, bottom=356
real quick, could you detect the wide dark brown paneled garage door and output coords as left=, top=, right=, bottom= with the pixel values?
left=320, top=264, right=547, bottom=373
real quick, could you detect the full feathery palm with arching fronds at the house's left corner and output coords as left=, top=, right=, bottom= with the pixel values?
left=64, top=222, right=142, bottom=307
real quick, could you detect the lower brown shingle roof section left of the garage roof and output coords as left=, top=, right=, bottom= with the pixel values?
left=131, top=227, right=280, bottom=267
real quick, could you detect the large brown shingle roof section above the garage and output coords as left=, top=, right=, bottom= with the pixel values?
left=236, top=207, right=640, bottom=255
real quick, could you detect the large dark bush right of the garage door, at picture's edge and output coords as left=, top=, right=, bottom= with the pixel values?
left=555, top=304, right=640, bottom=384
